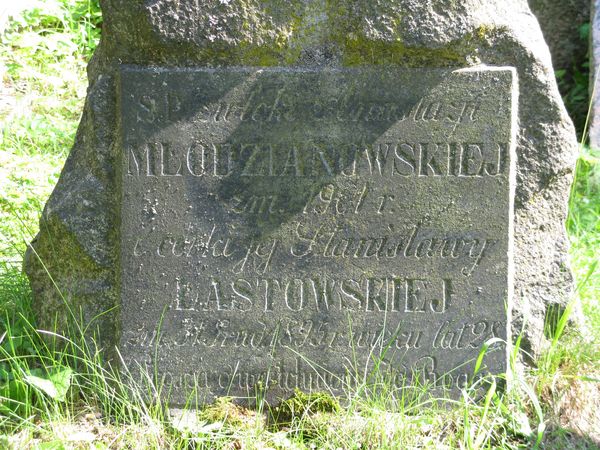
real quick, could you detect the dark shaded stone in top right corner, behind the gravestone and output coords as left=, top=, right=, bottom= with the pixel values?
left=529, top=0, right=594, bottom=69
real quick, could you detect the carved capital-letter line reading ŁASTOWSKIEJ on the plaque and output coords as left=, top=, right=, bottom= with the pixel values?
left=170, top=276, right=453, bottom=314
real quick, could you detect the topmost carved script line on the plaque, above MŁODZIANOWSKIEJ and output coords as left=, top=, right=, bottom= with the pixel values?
left=134, top=81, right=481, bottom=127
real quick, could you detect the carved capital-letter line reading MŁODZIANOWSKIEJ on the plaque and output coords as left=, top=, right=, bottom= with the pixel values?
left=127, top=142, right=509, bottom=178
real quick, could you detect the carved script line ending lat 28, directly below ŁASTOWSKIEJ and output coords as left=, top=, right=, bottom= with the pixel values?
left=124, top=318, right=504, bottom=351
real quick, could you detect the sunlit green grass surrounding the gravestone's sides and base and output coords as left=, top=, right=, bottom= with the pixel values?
left=0, top=0, right=600, bottom=449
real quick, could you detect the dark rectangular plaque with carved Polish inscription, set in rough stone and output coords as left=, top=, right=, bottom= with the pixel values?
left=118, top=66, right=517, bottom=404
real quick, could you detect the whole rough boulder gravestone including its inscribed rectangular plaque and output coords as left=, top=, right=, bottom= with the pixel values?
left=26, top=0, right=576, bottom=404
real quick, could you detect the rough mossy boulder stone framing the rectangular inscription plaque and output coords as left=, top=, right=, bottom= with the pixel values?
left=26, top=0, right=576, bottom=384
